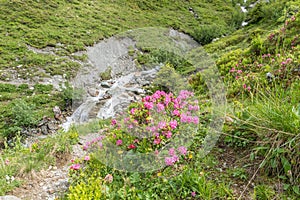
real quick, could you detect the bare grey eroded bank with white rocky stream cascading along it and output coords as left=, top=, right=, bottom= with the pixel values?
left=62, top=29, right=199, bottom=130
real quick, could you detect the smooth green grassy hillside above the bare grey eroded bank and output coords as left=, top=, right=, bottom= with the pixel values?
left=0, top=0, right=237, bottom=80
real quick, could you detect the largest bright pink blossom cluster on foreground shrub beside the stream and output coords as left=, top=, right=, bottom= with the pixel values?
left=107, top=90, right=200, bottom=166
